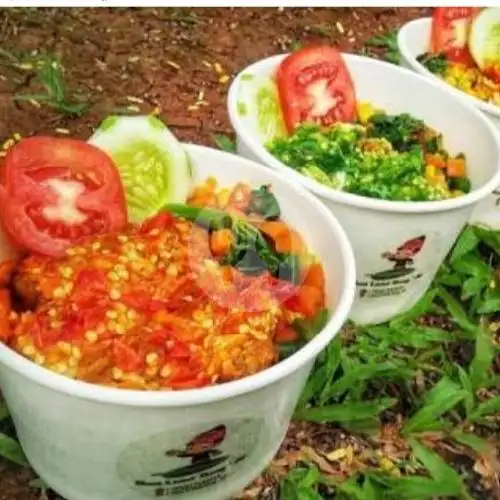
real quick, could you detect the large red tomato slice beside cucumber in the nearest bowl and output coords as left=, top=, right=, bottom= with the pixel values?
left=0, top=137, right=127, bottom=257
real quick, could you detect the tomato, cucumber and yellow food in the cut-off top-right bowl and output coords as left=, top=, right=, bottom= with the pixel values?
left=417, top=7, right=500, bottom=106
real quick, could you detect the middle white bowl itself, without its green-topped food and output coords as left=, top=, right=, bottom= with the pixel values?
left=228, top=54, right=500, bottom=323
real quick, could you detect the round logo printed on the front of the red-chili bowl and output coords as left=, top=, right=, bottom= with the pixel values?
left=117, top=419, right=263, bottom=498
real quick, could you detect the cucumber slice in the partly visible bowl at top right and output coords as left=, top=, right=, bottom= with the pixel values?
left=469, top=7, right=500, bottom=69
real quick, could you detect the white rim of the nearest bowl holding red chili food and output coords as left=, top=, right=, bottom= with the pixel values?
left=0, top=144, right=356, bottom=408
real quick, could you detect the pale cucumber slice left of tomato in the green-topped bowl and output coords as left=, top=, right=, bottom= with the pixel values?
left=236, top=73, right=286, bottom=143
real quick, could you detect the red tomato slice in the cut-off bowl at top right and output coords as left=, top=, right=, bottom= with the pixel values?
left=431, top=7, right=481, bottom=66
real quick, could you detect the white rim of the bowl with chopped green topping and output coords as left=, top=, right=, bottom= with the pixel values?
left=227, top=53, right=500, bottom=214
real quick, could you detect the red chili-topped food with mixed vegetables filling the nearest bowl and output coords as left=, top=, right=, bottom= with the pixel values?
left=0, top=116, right=328, bottom=390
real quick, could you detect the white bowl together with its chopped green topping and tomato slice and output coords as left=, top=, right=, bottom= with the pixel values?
left=228, top=47, right=500, bottom=323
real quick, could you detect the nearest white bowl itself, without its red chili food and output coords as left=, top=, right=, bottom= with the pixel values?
left=0, top=145, right=355, bottom=500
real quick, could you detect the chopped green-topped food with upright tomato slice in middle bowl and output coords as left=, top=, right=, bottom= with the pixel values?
left=236, top=47, right=471, bottom=201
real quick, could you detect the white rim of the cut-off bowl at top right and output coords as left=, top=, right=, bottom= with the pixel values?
left=397, top=17, right=500, bottom=120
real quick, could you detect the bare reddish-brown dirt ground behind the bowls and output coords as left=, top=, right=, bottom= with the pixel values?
left=0, top=8, right=426, bottom=500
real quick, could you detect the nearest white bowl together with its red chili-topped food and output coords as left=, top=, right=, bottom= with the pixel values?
left=0, top=123, right=355, bottom=500
